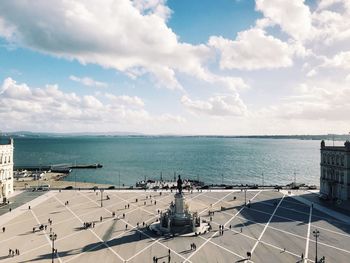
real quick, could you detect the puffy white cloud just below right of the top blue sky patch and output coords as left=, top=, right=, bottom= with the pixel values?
left=209, top=28, right=293, bottom=70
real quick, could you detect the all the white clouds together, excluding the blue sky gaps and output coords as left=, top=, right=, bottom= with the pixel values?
left=0, top=0, right=350, bottom=134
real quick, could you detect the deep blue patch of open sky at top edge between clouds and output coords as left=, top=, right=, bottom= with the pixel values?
left=168, top=0, right=261, bottom=44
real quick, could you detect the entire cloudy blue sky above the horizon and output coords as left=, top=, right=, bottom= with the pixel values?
left=0, top=0, right=350, bottom=135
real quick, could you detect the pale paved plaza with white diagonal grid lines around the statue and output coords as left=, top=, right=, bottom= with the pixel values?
left=0, top=190, right=350, bottom=263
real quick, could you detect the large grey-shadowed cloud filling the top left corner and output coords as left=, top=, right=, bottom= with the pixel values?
left=0, top=0, right=221, bottom=92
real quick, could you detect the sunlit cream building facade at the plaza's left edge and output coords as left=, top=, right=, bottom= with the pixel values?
left=0, top=139, right=14, bottom=202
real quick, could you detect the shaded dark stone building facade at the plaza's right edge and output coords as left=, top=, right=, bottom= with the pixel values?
left=320, top=141, right=350, bottom=200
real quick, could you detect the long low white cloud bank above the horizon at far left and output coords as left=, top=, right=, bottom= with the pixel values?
left=0, top=78, right=185, bottom=131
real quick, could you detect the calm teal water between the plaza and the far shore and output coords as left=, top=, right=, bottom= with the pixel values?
left=14, top=137, right=320, bottom=186
